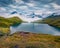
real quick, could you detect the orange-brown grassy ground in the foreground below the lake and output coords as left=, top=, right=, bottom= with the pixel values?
left=0, top=32, right=60, bottom=48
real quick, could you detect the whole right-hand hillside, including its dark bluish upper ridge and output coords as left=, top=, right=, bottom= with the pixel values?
left=42, top=15, right=60, bottom=28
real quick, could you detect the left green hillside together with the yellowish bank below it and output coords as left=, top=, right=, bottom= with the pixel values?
left=0, top=17, right=22, bottom=35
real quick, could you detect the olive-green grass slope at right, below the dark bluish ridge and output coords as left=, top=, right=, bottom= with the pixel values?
left=43, top=18, right=60, bottom=28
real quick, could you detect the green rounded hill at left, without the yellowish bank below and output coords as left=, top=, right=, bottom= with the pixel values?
left=0, top=17, right=22, bottom=27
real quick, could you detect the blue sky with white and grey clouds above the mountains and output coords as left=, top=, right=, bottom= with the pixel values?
left=0, top=0, right=60, bottom=16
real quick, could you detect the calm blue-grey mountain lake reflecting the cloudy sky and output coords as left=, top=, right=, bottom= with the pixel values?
left=10, top=23, right=60, bottom=35
